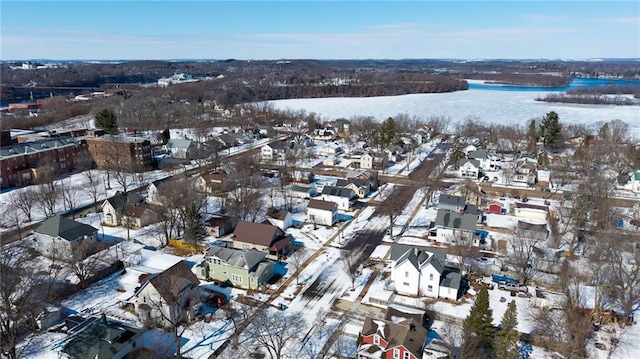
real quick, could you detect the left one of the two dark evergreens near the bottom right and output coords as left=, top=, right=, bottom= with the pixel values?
left=462, top=286, right=495, bottom=353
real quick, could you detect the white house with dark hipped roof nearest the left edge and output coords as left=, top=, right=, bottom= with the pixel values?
left=33, top=215, right=98, bottom=260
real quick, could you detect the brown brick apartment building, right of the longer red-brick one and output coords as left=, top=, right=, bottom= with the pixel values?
left=85, top=135, right=153, bottom=171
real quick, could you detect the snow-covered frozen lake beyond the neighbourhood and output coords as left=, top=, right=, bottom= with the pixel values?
left=270, top=89, right=640, bottom=139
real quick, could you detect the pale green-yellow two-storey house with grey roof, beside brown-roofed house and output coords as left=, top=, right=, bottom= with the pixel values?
left=193, top=246, right=274, bottom=290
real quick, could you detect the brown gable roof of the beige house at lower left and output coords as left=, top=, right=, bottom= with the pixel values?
left=140, top=260, right=200, bottom=305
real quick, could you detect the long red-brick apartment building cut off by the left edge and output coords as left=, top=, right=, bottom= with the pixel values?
left=0, top=137, right=86, bottom=188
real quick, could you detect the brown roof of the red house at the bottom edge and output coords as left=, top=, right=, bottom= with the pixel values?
left=362, top=317, right=427, bottom=357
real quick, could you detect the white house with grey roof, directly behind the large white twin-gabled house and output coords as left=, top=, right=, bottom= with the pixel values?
left=429, top=209, right=480, bottom=246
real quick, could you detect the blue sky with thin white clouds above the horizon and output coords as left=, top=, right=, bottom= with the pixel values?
left=0, top=0, right=640, bottom=60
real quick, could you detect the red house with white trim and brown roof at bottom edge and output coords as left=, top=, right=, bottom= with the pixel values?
left=358, top=317, right=427, bottom=359
